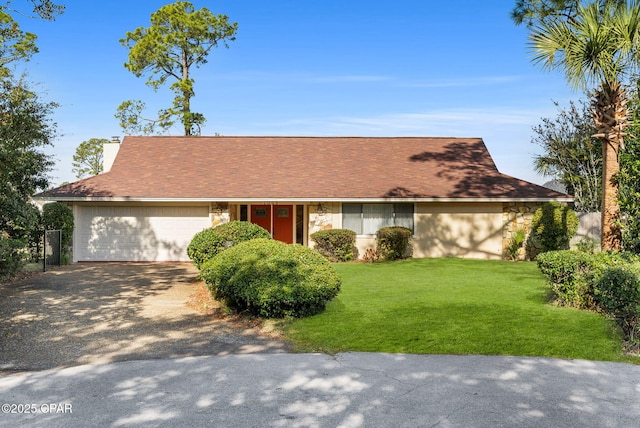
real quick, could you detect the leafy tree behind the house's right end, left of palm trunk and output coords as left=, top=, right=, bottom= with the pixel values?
left=532, top=101, right=602, bottom=212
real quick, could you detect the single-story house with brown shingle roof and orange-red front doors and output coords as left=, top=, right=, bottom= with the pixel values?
left=36, top=136, right=572, bottom=262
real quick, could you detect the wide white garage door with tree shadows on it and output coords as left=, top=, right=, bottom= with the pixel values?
left=74, top=206, right=211, bottom=261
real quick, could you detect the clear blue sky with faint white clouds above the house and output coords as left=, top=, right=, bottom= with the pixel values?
left=20, top=0, right=583, bottom=185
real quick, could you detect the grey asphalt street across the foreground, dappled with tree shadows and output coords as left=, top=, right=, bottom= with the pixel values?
left=0, top=353, right=640, bottom=427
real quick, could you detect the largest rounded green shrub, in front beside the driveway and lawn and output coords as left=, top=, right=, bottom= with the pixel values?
left=202, top=239, right=341, bottom=318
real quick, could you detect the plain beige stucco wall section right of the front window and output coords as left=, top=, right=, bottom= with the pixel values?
left=413, top=202, right=503, bottom=259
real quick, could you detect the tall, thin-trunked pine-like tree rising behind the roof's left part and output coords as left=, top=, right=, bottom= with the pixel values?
left=116, top=1, right=238, bottom=135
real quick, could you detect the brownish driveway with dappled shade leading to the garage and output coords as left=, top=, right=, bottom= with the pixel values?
left=0, top=263, right=287, bottom=371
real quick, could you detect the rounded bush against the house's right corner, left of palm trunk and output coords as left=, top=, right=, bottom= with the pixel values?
left=527, top=202, right=580, bottom=258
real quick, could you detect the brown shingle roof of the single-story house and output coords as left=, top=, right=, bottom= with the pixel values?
left=38, top=137, right=568, bottom=201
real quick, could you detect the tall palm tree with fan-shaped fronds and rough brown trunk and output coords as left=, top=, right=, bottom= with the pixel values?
left=530, top=0, right=640, bottom=251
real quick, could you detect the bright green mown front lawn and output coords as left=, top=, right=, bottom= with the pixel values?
left=284, top=259, right=637, bottom=362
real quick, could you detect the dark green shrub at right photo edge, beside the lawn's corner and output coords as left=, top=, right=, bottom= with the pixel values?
left=595, top=265, right=640, bottom=342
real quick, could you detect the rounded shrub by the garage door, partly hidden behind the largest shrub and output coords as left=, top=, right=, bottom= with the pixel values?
left=187, top=221, right=271, bottom=269
